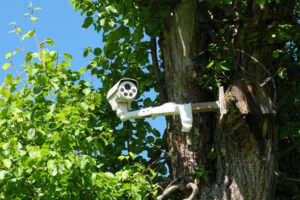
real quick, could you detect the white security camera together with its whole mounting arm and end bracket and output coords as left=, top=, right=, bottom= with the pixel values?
left=107, top=78, right=227, bottom=132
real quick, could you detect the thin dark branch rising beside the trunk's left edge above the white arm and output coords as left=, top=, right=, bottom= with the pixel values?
left=150, top=38, right=167, bottom=103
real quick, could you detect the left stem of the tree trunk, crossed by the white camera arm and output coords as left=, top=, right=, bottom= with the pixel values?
left=160, top=1, right=213, bottom=184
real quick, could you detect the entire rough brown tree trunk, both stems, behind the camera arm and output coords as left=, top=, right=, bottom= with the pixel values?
left=160, top=0, right=292, bottom=200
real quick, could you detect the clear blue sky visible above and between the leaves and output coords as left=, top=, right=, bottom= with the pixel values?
left=0, top=0, right=166, bottom=133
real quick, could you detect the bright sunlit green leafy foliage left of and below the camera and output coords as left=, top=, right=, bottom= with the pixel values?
left=0, top=2, right=157, bottom=199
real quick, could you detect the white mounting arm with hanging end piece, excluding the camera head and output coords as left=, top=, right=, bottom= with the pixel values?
left=119, top=103, right=193, bottom=132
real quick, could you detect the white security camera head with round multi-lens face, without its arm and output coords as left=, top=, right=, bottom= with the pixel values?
left=107, top=78, right=137, bottom=117
